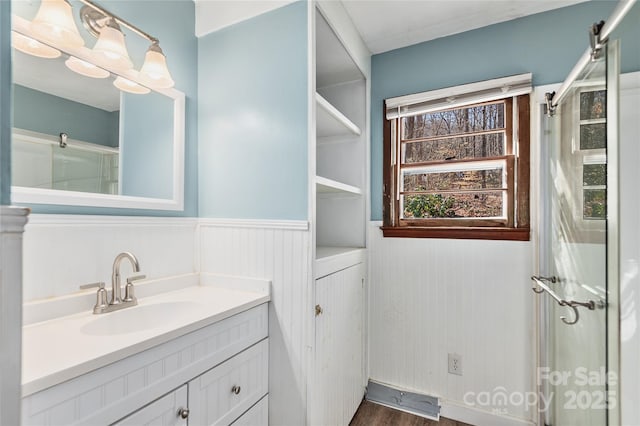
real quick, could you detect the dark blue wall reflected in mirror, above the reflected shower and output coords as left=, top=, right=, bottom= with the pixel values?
left=13, top=84, right=119, bottom=147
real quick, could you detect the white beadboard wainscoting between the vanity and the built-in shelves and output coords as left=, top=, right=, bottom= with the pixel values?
left=199, top=219, right=312, bottom=425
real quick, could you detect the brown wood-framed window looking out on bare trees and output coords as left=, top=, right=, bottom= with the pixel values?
left=382, top=74, right=532, bottom=240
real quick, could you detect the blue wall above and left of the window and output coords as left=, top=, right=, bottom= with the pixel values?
left=371, top=1, right=640, bottom=220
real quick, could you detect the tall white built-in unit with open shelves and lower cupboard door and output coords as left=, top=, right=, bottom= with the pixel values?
left=307, top=0, right=371, bottom=425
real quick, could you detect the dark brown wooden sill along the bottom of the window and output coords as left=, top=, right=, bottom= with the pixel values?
left=380, top=226, right=530, bottom=241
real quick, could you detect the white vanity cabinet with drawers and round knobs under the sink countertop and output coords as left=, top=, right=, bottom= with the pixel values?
left=22, top=303, right=269, bottom=426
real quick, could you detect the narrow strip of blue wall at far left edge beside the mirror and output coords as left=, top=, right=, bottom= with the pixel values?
left=0, top=1, right=12, bottom=205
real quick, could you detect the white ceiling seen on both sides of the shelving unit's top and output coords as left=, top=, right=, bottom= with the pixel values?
left=195, top=0, right=588, bottom=54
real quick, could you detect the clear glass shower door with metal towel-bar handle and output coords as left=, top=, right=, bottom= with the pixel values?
left=536, top=43, right=618, bottom=426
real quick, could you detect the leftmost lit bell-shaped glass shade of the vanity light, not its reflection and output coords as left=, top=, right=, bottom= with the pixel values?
left=31, top=0, right=84, bottom=48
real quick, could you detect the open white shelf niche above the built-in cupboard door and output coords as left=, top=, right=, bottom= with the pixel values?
left=314, top=10, right=367, bottom=278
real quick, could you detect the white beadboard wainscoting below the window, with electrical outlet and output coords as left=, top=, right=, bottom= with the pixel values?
left=369, top=222, right=535, bottom=425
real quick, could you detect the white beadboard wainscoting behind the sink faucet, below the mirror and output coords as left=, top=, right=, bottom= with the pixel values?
left=23, top=214, right=198, bottom=302
